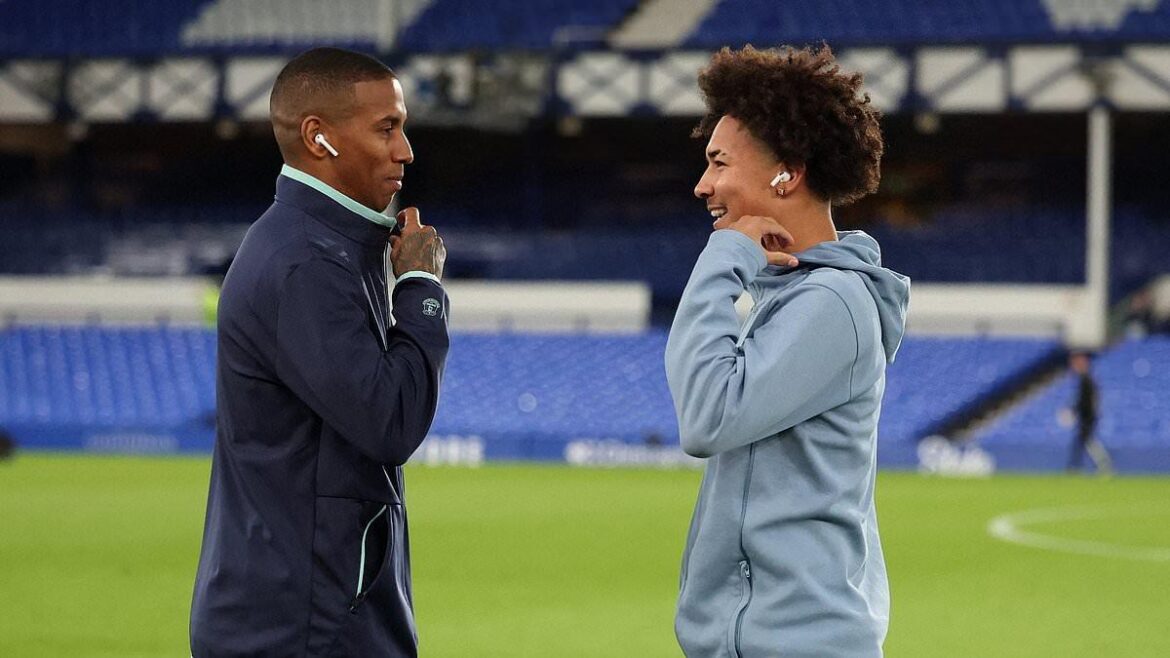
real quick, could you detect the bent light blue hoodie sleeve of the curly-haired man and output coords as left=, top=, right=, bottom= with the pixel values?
left=666, top=231, right=858, bottom=457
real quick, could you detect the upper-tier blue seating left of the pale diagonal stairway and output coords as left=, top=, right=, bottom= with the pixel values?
left=0, top=0, right=638, bottom=57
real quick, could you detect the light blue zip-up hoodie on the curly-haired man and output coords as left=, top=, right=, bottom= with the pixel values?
left=666, top=231, right=910, bottom=658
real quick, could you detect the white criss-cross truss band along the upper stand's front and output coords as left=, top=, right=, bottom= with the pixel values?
left=0, top=44, right=1170, bottom=123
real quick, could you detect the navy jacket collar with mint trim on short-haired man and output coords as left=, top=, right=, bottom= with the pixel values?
left=276, top=165, right=398, bottom=245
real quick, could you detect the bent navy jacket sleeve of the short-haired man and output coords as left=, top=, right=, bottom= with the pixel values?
left=276, top=254, right=448, bottom=465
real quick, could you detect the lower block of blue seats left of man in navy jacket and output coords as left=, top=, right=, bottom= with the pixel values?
left=0, top=325, right=215, bottom=451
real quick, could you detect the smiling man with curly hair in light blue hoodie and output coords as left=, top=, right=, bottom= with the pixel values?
left=666, top=46, right=909, bottom=658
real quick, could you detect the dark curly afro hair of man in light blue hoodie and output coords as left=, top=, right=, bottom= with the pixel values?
left=693, top=44, right=883, bottom=205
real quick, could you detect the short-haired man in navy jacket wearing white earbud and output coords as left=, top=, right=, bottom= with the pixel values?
left=191, top=48, right=448, bottom=658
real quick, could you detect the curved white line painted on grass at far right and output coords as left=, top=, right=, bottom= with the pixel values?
left=987, top=506, right=1170, bottom=562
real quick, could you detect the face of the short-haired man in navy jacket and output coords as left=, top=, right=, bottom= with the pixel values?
left=321, top=77, right=414, bottom=211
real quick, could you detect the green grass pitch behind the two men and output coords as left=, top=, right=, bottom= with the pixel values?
left=0, top=454, right=1170, bottom=658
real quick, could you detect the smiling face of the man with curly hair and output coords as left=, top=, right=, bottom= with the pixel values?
left=695, top=116, right=783, bottom=221
